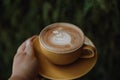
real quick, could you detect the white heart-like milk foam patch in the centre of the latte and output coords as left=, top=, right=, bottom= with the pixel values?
left=50, top=30, right=71, bottom=45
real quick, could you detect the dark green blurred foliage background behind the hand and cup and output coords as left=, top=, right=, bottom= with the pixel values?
left=0, top=0, right=120, bottom=80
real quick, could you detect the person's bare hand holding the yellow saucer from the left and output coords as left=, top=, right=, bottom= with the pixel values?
left=9, top=36, right=38, bottom=80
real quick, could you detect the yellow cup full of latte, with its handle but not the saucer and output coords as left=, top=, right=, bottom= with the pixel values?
left=33, top=23, right=95, bottom=65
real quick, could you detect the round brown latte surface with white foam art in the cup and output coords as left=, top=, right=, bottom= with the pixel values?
left=40, top=23, right=84, bottom=53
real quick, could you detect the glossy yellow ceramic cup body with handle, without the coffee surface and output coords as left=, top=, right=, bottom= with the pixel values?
left=33, top=23, right=95, bottom=65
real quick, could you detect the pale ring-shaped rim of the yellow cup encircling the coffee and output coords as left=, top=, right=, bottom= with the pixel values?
left=39, top=22, right=85, bottom=54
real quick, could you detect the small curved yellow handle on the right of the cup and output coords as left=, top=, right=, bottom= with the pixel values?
left=80, top=44, right=95, bottom=58
